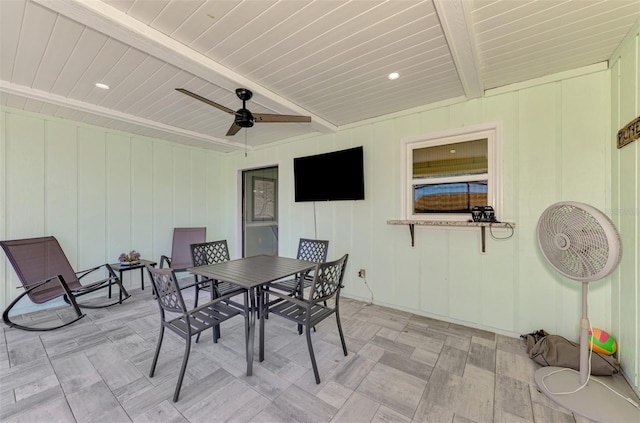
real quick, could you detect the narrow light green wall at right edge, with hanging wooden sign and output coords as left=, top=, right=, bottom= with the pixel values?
left=609, top=26, right=640, bottom=390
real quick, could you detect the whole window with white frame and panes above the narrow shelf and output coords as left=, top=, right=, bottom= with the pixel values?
left=402, top=123, right=502, bottom=220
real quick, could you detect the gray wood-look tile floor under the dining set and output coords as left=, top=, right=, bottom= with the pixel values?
left=0, top=289, right=633, bottom=423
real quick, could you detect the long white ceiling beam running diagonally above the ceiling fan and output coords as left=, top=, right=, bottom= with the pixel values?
left=32, top=0, right=338, bottom=133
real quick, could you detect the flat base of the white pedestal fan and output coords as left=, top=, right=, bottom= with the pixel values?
left=535, top=367, right=640, bottom=422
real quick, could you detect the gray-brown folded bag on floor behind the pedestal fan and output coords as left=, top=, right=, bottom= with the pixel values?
left=520, top=329, right=620, bottom=376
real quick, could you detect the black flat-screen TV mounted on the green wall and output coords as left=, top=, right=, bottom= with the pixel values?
left=293, top=147, right=364, bottom=202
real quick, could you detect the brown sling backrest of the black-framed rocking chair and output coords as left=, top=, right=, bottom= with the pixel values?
left=0, top=236, right=81, bottom=304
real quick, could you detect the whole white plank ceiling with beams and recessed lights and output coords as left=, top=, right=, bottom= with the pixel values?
left=0, top=0, right=640, bottom=152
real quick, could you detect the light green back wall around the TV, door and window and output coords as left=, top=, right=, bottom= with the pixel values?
left=218, top=64, right=638, bottom=389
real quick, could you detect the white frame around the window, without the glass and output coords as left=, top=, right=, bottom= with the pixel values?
left=400, top=122, right=502, bottom=221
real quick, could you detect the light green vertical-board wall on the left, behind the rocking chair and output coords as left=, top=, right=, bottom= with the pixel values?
left=0, top=109, right=225, bottom=312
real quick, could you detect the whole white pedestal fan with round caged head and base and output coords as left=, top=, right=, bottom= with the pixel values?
left=535, top=201, right=640, bottom=422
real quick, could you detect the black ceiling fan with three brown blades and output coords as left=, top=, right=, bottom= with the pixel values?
left=176, top=88, right=311, bottom=136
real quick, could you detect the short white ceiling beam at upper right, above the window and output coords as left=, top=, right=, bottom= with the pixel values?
left=433, top=0, right=484, bottom=99
